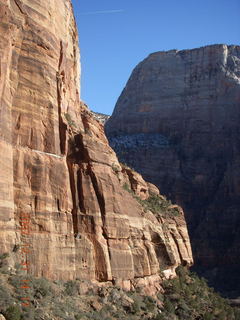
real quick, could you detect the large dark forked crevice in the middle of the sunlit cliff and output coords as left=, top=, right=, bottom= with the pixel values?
left=67, top=133, right=110, bottom=282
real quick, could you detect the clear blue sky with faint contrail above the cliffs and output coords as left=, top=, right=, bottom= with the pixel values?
left=73, top=0, right=240, bottom=114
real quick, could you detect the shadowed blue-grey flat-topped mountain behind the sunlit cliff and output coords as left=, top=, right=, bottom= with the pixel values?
left=106, top=45, right=240, bottom=296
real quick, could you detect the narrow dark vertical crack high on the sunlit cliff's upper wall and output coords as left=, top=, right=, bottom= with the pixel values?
left=56, top=41, right=67, bottom=154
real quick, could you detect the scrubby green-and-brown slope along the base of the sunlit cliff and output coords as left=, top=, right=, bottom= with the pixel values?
left=0, top=257, right=240, bottom=320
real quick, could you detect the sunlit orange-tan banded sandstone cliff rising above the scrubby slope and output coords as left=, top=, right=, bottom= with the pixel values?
left=0, top=0, right=192, bottom=292
